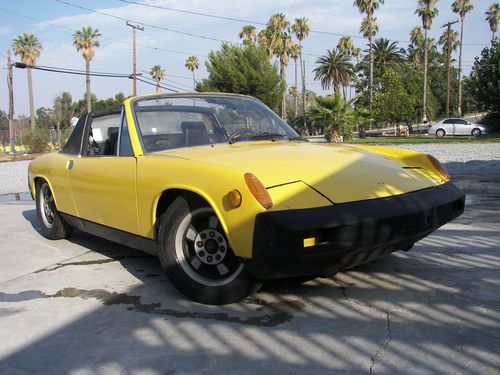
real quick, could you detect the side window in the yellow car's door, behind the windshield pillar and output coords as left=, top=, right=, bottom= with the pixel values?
left=85, top=114, right=120, bottom=156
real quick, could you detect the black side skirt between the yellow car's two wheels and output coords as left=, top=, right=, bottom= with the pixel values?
left=60, top=212, right=158, bottom=256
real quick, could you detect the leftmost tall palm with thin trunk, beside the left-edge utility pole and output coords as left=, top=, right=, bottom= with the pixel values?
left=12, top=33, right=42, bottom=130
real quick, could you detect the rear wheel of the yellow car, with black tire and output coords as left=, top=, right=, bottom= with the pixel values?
left=35, top=180, right=73, bottom=240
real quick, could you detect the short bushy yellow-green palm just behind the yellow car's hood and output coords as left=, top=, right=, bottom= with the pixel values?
left=307, top=92, right=356, bottom=143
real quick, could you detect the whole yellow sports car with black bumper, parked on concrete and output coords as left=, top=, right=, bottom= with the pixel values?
left=29, top=93, right=464, bottom=304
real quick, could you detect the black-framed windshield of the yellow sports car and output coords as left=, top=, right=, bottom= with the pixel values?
left=133, top=95, right=300, bottom=152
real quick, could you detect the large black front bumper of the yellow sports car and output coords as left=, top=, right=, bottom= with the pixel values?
left=245, top=182, right=465, bottom=279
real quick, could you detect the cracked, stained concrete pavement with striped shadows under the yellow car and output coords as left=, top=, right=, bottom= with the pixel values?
left=0, top=176, right=500, bottom=374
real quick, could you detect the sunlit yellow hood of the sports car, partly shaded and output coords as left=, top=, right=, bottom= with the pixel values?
left=153, top=141, right=440, bottom=203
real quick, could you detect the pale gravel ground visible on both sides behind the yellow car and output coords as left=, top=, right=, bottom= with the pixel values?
left=0, top=143, right=500, bottom=195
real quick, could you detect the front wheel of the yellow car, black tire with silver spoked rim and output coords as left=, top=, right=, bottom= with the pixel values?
left=158, top=197, right=261, bottom=305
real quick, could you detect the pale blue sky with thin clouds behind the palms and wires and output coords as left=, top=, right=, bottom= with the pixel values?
left=0, top=0, right=493, bottom=115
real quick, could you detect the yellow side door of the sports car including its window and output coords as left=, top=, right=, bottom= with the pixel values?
left=67, top=109, right=139, bottom=233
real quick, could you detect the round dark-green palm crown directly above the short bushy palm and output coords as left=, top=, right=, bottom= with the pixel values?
left=313, top=49, right=354, bottom=98
